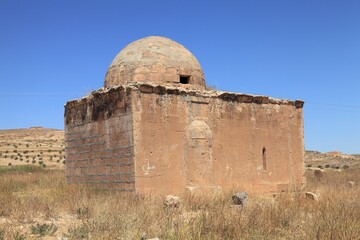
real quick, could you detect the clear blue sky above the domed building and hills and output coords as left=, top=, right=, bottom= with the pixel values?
left=0, top=0, right=360, bottom=153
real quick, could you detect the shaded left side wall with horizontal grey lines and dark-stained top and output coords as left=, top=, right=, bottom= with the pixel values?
left=65, top=88, right=135, bottom=191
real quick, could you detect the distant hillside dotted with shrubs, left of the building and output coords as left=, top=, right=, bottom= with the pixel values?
left=0, top=127, right=65, bottom=168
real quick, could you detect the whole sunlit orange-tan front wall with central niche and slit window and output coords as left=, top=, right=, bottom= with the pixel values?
left=132, top=85, right=304, bottom=193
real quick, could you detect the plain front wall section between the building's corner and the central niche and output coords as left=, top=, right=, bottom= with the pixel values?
left=133, top=87, right=188, bottom=193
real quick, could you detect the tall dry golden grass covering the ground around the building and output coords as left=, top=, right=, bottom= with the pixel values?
left=0, top=168, right=360, bottom=239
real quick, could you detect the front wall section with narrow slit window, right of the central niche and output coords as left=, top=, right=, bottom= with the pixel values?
left=208, top=96, right=304, bottom=191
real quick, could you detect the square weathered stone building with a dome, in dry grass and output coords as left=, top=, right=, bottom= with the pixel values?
left=65, top=37, right=304, bottom=194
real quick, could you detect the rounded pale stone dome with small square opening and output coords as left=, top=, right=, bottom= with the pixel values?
left=104, top=36, right=205, bottom=89
